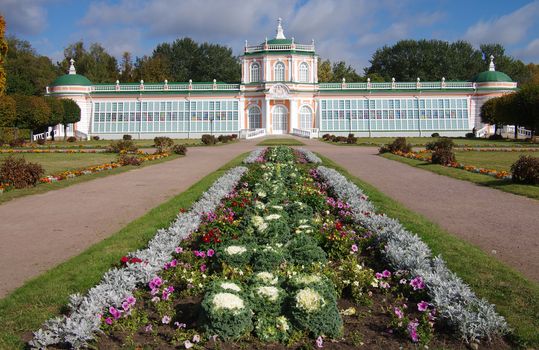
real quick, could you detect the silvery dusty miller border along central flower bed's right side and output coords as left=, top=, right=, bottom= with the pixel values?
left=317, top=166, right=508, bottom=342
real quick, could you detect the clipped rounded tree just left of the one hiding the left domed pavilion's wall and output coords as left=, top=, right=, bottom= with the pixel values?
left=13, top=95, right=51, bottom=131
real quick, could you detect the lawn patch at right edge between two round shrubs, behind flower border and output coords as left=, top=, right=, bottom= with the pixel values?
left=455, top=151, right=539, bottom=171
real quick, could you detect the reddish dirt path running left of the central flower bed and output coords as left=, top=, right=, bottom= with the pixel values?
left=0, top=140, right=259, bottom=298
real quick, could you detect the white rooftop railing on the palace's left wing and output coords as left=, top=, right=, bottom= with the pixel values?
left=91, top=83, right=240, bottom=92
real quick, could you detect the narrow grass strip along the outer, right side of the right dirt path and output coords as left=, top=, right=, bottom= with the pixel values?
left=382, top=152, right=539, bottom=199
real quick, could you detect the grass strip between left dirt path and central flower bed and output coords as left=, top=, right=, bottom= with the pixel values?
left=0, top=154, right=246, bottom=349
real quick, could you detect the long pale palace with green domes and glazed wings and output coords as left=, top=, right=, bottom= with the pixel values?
left=47, top=19, right=517, bottom=139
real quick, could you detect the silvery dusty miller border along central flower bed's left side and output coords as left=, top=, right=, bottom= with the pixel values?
left=29, top=167, right=247, bottom=349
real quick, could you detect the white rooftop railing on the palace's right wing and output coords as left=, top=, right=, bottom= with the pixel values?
left=319, top=81, right=475, bottom=91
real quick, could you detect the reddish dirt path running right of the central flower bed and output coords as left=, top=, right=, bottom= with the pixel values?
left=302, top=140, right=539, bottom=281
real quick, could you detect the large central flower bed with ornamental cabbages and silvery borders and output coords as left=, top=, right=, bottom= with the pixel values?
left=31, top=147, right=507, bottom=349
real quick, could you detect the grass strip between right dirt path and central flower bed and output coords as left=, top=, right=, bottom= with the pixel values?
left=319, top=155, right=539, bottom=348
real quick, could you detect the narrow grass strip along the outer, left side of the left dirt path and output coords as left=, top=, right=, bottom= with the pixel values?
left=0, top=153, right=182, bottom=205
